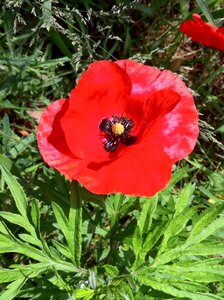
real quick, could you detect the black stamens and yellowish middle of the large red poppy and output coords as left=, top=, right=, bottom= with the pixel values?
left=99, top=115, right=136, bottom=152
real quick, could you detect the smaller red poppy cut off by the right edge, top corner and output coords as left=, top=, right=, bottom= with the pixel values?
left=179, top=14, right=224, bottom=50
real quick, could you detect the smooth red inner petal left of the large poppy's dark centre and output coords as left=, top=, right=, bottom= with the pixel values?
left=61, top=61, right=131, bottom=161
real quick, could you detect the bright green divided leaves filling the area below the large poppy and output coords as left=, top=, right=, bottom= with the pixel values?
left=0, top=166, right=224, bottom=299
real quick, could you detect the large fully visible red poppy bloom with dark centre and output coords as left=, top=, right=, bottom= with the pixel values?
left=37, top=60, right=198, bottom=196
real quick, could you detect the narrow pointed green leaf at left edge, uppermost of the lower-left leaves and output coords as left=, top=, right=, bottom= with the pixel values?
left=0, top=166, right=27, bottom=218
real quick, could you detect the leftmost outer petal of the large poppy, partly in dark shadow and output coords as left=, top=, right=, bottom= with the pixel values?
left=37, top=99, right=80, bottom=179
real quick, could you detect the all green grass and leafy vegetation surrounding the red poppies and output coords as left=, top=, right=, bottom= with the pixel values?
left=0, top=0, right=224, bottom=300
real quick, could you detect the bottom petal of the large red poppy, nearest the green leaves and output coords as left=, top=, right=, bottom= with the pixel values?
left=79, top=141, right=172, bottom=197
